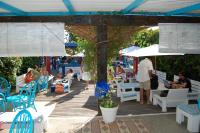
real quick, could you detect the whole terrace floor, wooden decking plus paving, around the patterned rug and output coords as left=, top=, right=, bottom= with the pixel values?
left=36, top=80, right=192, bottom=133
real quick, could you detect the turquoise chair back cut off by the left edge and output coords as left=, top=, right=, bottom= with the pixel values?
left=0, top=77, right=11, bottom=97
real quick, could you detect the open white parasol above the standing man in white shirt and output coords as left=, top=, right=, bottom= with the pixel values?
left=126, top=44, right=184, bottom=57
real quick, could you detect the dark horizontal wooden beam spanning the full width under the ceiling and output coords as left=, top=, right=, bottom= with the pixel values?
left=0, top=15, right=200, bottom=26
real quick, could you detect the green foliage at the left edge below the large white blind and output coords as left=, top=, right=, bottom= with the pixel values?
left=0, top=57, right=22, bottom=84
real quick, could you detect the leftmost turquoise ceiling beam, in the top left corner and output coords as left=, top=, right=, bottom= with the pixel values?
left=0, top=1, right=26, bottom=15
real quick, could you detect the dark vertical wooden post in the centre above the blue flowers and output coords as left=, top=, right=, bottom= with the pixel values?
left=96, top=24, right=108, bottom=82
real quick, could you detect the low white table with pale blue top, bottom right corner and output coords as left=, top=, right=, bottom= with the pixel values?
left=176, top=104, right=200, bottom=132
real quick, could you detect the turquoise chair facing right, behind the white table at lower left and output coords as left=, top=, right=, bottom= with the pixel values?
left=6, top=81, right=37, bottom=111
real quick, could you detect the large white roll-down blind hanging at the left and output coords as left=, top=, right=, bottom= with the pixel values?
left=0, top=23, right=66, bottom=57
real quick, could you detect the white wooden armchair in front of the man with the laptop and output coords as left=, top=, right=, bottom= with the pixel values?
left=153, top=88, right=188, bottom=112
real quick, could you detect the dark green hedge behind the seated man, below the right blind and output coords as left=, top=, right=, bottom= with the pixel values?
left=157, top=55, right=200, bottom=81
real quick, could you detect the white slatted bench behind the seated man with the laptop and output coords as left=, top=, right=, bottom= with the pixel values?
left=174, top=75, right=200, bottom=100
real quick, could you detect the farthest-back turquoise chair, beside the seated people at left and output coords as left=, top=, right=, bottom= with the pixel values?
left=37, top=76, right=49, bottom=92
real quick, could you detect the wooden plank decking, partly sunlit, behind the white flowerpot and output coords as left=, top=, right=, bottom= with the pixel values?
left=36, top=80, right=175, bottom=116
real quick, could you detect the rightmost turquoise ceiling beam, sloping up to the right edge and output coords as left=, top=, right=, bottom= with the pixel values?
left=166, top=3, right=200, bottom=15
